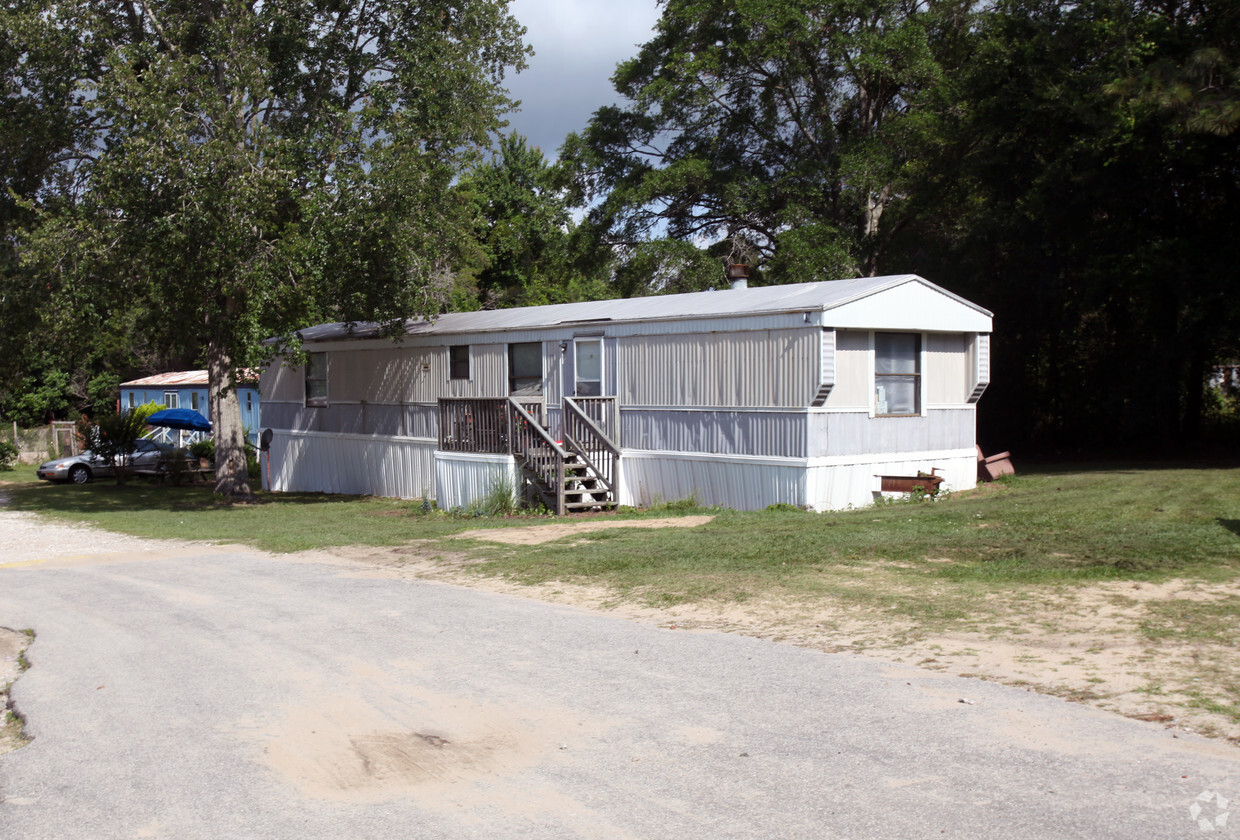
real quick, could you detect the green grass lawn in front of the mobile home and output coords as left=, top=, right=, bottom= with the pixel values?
left=0, top=459, right=1240, bottom=583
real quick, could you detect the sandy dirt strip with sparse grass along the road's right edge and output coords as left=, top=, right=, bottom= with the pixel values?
left=322, top=543, right=1240, bottom=743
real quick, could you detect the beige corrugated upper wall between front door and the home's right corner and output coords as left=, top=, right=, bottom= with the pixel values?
left=616, top=329, right=818, bottom=408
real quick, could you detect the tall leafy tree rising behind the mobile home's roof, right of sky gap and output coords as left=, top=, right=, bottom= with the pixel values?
left=565, top=0, right=968, bottom=282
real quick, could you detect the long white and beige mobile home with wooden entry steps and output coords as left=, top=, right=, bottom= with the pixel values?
left=259, top=274, right=992, bottom=511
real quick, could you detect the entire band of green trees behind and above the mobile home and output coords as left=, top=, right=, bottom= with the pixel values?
left=0, top=0, right=1240, bottom=459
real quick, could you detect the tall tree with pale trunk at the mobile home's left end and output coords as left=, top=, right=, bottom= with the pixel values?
left=4, top=0, right=526, bottom=495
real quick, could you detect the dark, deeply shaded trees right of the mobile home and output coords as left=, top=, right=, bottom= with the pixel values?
left=897, top=0, right=1240, bottom=452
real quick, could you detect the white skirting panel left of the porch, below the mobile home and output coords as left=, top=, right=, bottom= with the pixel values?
left=260, top=429, right=436, bottom=499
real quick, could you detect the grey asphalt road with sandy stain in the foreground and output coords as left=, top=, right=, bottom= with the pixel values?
left=0, top=547, right=1240, bottom=840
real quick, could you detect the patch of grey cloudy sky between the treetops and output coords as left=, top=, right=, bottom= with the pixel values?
left=505, top=0, right=660, bottom=159
